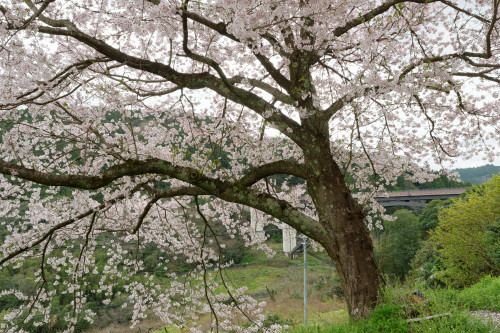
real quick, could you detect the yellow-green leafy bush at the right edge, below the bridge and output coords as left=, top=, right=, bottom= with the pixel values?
left=431, top=175, right=500, bottom=287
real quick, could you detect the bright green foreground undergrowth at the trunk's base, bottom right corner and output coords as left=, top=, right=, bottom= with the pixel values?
left=290, top=277, right=500, bottom=333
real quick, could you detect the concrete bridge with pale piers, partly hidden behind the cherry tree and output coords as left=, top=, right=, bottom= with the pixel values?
left=250, top=188, right=466, bottom=253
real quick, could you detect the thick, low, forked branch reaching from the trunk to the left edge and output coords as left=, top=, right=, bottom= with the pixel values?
left=0, top=159, right=326, bottom=241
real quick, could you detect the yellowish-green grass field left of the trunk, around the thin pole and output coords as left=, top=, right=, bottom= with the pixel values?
left=152, top=243, right=340, bottom=333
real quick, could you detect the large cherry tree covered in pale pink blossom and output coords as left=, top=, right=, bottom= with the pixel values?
left=0, top=0, right=500, bottom=331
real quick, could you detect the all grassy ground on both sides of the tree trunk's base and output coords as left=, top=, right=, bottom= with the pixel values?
left=94, top=244, right=500, bottom=333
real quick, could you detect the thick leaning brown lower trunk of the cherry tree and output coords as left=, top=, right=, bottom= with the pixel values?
left=305, top=140, right=380, bottom=320
